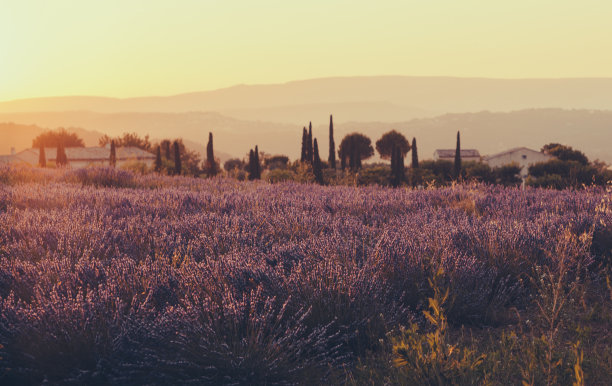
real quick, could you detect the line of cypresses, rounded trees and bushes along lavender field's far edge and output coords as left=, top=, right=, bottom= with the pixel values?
left=27, top=123, right=612, bottom=189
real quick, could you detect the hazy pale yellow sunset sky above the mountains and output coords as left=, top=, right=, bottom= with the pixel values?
left=0, top=0, right=612, bottom=100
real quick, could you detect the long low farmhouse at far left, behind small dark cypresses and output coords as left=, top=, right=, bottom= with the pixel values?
left=0, top=146, right=155, bottom=168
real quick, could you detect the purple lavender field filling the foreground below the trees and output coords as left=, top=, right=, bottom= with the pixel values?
left=0, top=168, right=612, bottom=384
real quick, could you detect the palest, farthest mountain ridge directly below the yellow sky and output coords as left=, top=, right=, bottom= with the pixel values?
left=0, top=76, right=612, bottom=123
